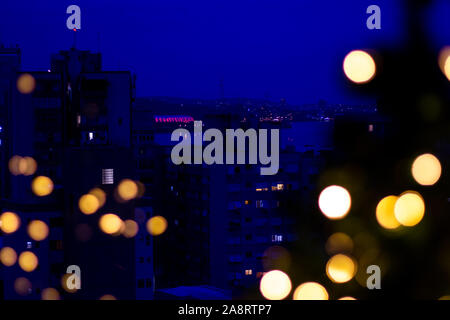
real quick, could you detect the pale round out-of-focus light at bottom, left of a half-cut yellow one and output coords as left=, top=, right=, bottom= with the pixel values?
left=259, top=270, right=292, bottom=300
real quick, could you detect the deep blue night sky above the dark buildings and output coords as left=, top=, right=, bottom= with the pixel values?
left=0, top=0, right=450, bottom=103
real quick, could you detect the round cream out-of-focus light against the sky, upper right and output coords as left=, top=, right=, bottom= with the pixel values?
left=343, top=50, right=376, bottom=83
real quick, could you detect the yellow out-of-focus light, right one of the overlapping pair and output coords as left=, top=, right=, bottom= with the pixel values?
left=394, top=191, right=425, bottom=227
